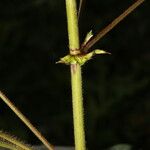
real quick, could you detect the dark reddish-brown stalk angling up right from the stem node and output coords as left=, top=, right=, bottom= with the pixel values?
left=80, top=0, right=144, bottom=52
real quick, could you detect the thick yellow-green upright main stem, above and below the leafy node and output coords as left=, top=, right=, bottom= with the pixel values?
left=66, top=0, right=86, bottom=150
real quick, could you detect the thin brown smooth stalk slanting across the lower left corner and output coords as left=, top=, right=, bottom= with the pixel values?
left=0, top=91, right=53, bottom=150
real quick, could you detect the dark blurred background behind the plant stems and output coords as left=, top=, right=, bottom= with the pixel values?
left=0, top=0, right=150, bottom=150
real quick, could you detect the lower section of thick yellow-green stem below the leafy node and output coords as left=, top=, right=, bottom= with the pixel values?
left=71, top=64, right=86, bottom=150
